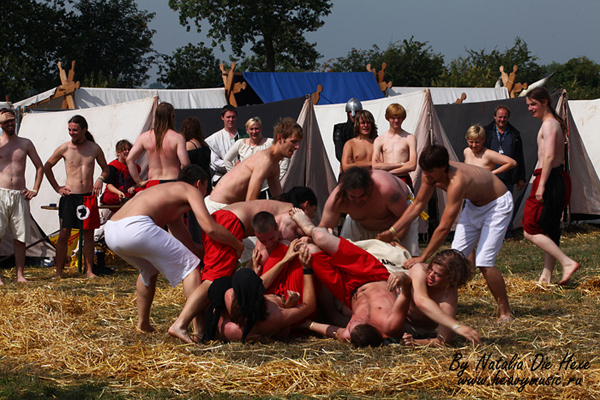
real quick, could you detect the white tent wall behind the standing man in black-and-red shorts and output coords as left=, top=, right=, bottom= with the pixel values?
left=19, top=97, right=157, bottom=239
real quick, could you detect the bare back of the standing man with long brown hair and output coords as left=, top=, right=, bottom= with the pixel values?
left=134, top=129, right=190, bottom=180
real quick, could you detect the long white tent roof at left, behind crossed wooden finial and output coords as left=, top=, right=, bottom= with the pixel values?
left=14, top=87, right=227, bottom=110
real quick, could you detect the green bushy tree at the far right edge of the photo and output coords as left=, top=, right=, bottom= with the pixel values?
left=545, top=57, right=600, bottom=100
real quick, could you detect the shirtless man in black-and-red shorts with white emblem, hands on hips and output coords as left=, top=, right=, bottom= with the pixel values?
left=44, top=115, right=110, bottom=278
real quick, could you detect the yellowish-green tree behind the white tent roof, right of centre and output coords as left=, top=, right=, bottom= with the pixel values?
left=435, top=37, right=544, bottom=87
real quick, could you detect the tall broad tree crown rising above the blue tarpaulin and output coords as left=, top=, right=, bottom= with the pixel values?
left=169, top=0, right=332, bottom=72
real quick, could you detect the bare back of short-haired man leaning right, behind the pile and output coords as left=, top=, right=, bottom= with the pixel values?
left=210, top=148, right=281, bottom=204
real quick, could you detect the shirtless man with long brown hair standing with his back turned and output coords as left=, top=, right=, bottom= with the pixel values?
left=127, top=103, right=190, bottom=187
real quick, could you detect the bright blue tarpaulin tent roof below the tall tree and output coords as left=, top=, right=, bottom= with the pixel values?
left=243, top=72, right=383, bottom=104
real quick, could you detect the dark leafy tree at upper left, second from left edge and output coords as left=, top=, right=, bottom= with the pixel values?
left=60, top=0, right=155, bottom=87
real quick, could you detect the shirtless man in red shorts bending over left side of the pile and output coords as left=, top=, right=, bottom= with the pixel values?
left=169, top=192, right=316, bottom=343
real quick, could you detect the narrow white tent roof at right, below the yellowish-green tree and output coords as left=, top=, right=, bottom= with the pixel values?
left=388, top=86, right=509, bottom=105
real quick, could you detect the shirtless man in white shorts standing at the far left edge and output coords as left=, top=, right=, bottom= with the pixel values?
left=0, top=108, right=44, bottom=285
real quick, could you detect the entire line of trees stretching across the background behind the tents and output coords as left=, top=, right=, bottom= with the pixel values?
left=0, top=0, right=600, bottom=101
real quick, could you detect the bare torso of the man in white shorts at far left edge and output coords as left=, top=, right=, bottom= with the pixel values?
left=0, top=137, right=41, bottom=190
